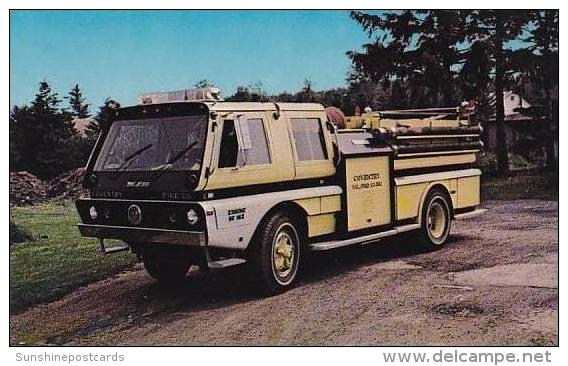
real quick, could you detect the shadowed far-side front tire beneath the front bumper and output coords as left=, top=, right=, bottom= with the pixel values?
left=142, top=249, right=191, bottom=283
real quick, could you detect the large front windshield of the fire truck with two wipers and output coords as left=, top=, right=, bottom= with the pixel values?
left=95, top=116, right=207, bottom=171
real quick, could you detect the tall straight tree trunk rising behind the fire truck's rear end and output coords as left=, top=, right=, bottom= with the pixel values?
left=495, top=11, right=509, bottom=175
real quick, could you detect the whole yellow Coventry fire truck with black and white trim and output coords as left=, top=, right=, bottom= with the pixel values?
left=76, top=88, right=483, bottom=293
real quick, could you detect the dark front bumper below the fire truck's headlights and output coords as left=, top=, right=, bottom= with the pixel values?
left=77, top=224, right=207, bottom=246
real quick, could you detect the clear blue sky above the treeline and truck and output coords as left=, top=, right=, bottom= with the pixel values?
left=10, top=11, right=368, bottom=108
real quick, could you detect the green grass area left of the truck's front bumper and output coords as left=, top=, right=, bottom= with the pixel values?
left=10, top=201, right=136, bottom=313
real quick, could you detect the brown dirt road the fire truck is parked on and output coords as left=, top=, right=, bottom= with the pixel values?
left=10, top=200, right=558, bottom=345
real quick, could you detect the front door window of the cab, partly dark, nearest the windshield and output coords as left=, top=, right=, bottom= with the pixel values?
left=218, top=118, right=271, bottom=168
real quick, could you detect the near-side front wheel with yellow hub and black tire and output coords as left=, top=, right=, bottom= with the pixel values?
left=250, top=211, right=302, bottom=295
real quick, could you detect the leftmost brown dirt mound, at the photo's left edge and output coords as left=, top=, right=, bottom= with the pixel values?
left=10, top=171, right=47, bottom=206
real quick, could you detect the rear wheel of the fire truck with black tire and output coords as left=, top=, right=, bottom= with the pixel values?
left=419, top=188, right=452, bottom=250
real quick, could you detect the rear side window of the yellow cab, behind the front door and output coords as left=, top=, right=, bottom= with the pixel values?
left=290, top=118, right=327, bottom=161
